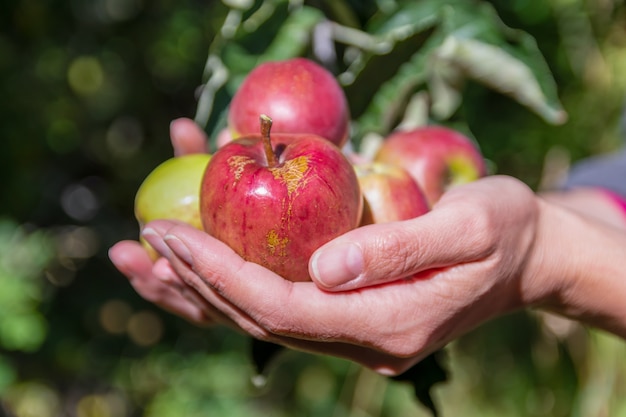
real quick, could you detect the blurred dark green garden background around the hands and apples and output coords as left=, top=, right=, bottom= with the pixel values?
left=0, top=0, right=626, bottom=417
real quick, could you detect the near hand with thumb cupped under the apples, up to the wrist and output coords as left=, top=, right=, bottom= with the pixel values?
left=136, top=176, right=543, bottom=374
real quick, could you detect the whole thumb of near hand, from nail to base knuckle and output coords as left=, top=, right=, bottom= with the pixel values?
left=309, top=176, right=534, bottom=290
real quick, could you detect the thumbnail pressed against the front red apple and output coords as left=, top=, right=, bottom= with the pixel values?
left=311, top=243, right=365, bottom=288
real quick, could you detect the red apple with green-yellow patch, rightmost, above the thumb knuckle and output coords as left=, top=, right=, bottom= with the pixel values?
left=374, top=125, right=487, bottom=207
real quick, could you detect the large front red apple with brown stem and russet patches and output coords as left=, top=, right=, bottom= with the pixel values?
left=200, top=116, right=362, bottom=281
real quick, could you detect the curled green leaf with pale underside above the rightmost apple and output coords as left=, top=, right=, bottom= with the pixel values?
left=347, top=0, right=566, bottom=142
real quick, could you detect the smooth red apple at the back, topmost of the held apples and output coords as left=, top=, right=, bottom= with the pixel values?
left=228, top=58, right=350, bottom=147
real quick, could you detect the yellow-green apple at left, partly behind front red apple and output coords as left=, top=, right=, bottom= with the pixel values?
left=135, top=154, right=211, bottom=259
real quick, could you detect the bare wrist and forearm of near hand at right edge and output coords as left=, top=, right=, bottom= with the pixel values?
left=522, top=199, right=626, bottom=337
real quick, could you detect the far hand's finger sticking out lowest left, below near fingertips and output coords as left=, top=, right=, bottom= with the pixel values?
left=109, top=241, right=211, bottom=326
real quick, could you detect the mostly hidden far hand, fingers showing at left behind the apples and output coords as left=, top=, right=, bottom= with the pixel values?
left=109, top=118, right=214, bottom=325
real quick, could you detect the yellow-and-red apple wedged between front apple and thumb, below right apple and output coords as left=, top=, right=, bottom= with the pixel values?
left=354, top=162, right=429, bottom=226
